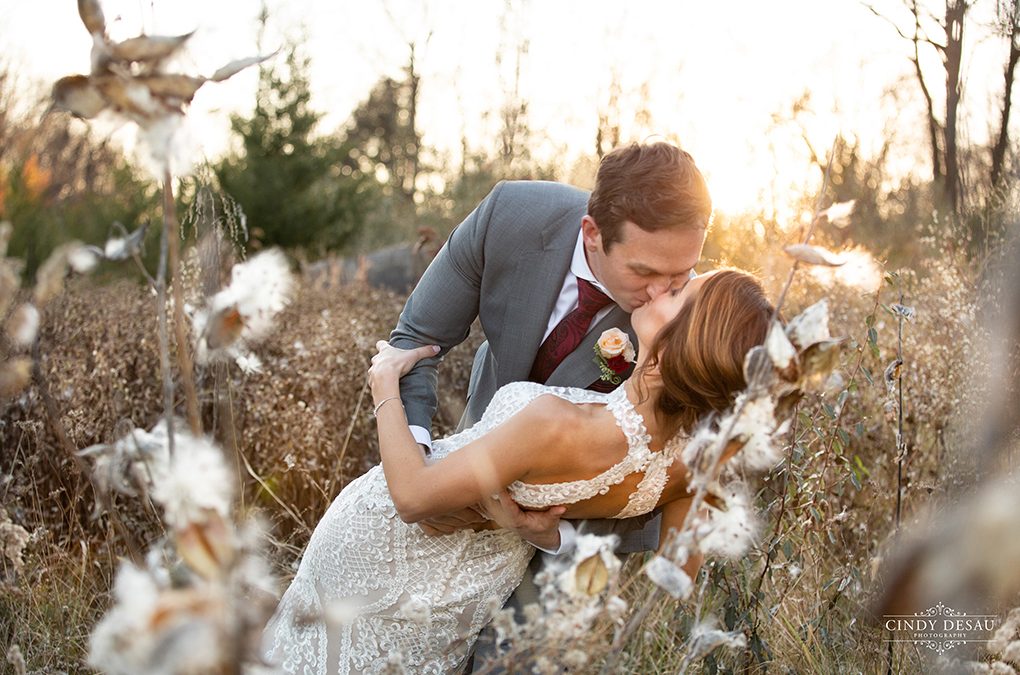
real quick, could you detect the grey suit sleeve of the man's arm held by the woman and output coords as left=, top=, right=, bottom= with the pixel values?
left=390, top=183, right=504, bottom=432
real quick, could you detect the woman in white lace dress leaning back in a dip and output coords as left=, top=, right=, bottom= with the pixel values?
left=265, top=271, right=771, bottom=675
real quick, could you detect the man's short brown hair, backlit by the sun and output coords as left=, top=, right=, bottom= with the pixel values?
left=588, top=142, right=712, bottom=252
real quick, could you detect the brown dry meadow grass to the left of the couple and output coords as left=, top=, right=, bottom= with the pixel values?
left=0, top=273, right=478, bottom=672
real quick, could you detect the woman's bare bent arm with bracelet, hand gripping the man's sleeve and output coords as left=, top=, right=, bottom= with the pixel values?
left=369, top=343, right=570, bottom=523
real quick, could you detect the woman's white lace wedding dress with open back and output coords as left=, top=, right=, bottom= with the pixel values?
left=264, top=382, right=676, bottom=675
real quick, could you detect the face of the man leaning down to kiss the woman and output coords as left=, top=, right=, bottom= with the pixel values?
left=581, top=216, right=706, bottom=313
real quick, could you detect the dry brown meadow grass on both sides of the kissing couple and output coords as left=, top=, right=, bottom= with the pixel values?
left=0, top=235, right=1003, bottom=673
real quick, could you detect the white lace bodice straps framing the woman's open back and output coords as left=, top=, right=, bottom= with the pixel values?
left=434, top=382, right=679, bottom=518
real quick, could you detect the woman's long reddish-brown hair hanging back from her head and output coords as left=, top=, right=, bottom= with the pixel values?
left=639, top=269, right=773, bottom=437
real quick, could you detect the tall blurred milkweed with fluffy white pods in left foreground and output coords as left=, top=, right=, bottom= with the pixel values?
left=29, top=0, right=293, bottom=673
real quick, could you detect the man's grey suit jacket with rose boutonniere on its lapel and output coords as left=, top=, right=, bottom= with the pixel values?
left=390, top=181, right=658, bottom=550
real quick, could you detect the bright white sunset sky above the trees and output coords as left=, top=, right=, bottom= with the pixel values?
left=0, top=0, right=1005, bottom=217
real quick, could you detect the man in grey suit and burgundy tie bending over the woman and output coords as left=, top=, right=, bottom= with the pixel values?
left=390, top=143, right=712, bottom=591
